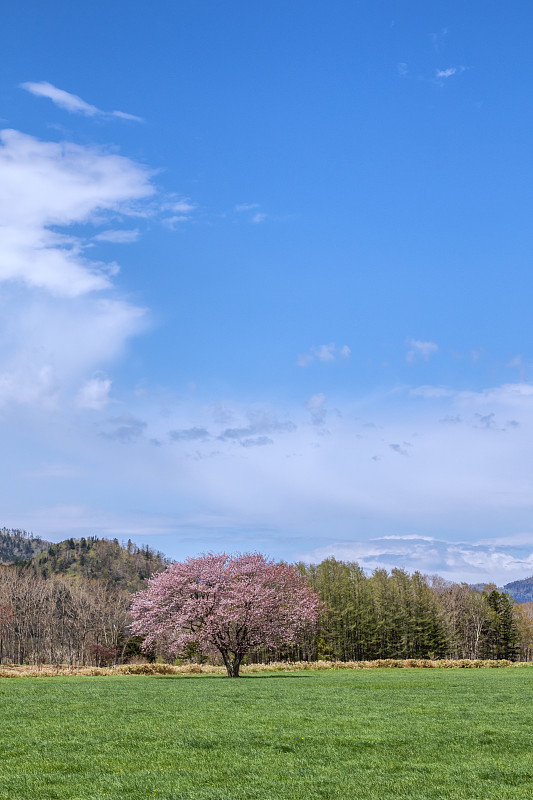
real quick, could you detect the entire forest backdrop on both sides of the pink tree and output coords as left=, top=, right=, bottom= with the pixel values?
left=0, top=529, right=533, bottom=665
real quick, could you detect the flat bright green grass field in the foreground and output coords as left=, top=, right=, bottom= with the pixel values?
left=0, top=668, right=533, bottom=800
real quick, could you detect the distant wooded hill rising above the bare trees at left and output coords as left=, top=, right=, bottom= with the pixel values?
left=0, top=528, right=170, bottom=592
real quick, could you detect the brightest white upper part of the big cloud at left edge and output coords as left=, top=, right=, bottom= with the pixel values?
left=0, top=130, right=154, bottom=297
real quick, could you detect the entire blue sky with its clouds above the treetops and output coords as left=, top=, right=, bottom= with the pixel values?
left=0, top=0, right=533, bottom=583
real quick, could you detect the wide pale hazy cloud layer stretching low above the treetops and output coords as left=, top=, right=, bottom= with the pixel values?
left=0, top=378, right=533, bottom=581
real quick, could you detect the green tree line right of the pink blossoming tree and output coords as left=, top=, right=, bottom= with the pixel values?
left=298, top=558, right=533, bottom=661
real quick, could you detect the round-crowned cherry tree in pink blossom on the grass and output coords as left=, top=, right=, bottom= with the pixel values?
left=131, top=553, right=323, bottom=678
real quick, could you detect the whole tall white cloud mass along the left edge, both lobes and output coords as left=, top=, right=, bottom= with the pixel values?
left=0, top=130, right=154, bottom=408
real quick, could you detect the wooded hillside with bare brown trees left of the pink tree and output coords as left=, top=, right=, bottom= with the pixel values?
left=0, top=530, right=169, bottom=664
